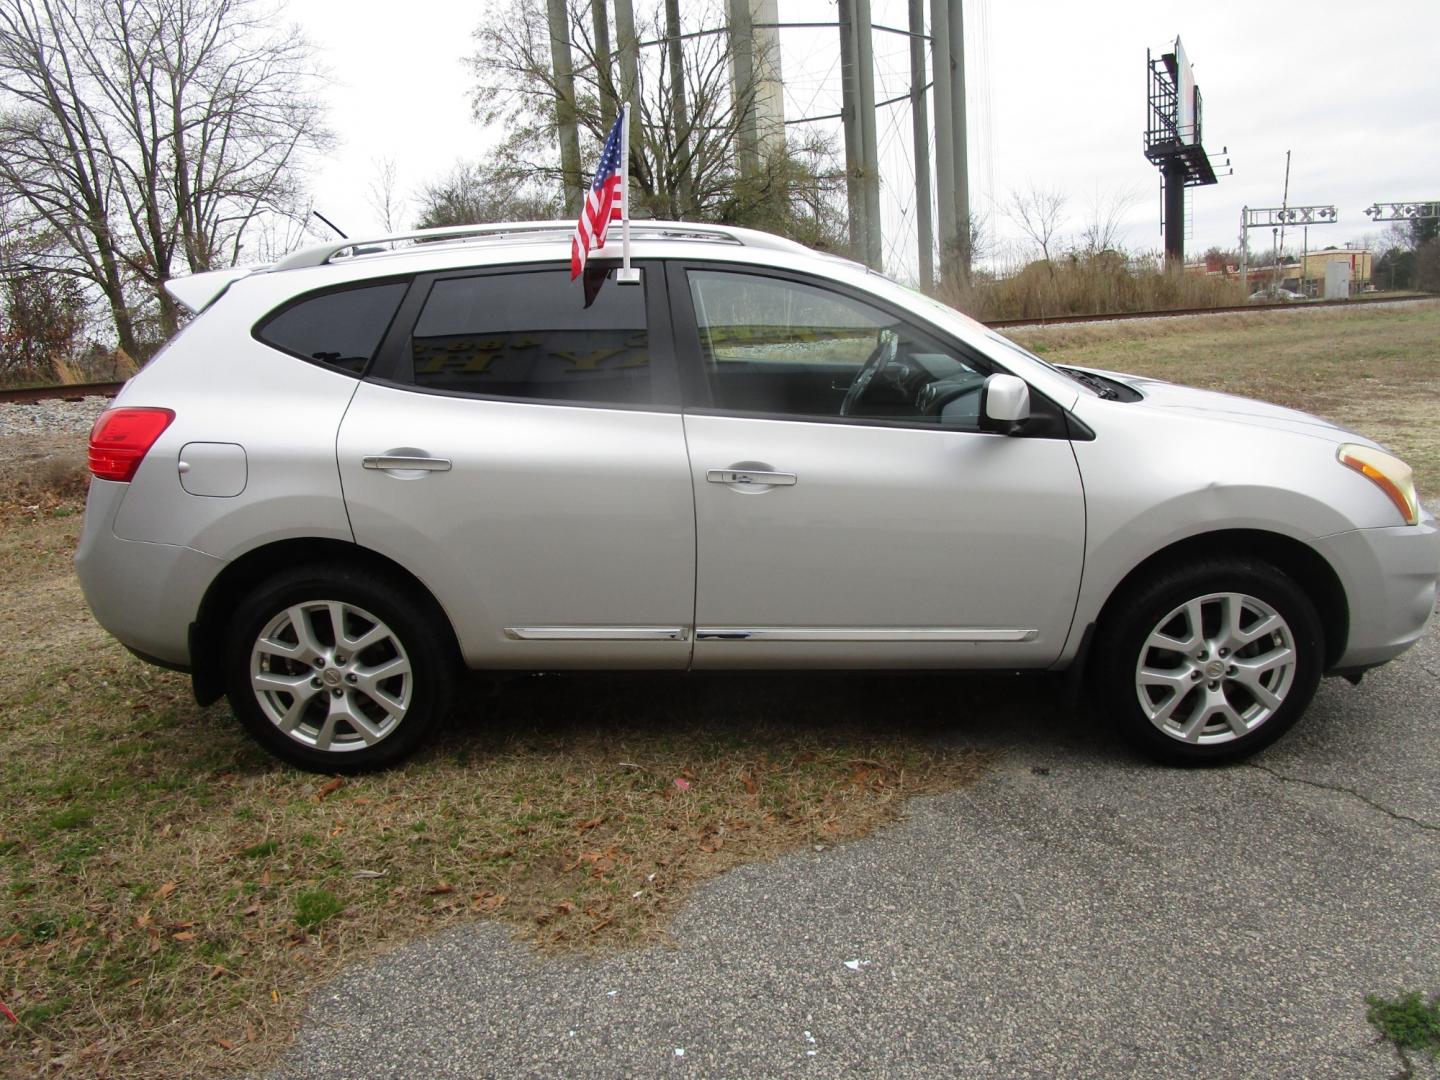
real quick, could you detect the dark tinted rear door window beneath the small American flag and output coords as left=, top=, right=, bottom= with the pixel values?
left=410, top=271, right=654, bottom=403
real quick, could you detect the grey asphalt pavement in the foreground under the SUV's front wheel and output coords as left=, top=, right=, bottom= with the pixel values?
left=269, top=601, right=1440, bottom=1080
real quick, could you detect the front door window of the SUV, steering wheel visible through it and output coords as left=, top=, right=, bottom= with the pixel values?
left=688, top=271, right=985, bottom=429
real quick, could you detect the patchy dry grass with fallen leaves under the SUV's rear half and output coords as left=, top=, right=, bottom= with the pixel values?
left=0, top=500, right=982, bottom=1076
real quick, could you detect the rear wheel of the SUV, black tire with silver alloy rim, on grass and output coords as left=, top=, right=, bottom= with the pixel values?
left=222, top=566, right=459, bottom=773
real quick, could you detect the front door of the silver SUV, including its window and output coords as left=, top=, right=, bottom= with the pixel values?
left=671, top=265, right=1084, bottom=668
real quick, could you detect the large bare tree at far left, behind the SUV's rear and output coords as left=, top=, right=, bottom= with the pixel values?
left=0, top=0, right=327, bottom=354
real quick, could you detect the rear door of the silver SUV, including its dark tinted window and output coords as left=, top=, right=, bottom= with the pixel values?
left=337, top=266, right=694, bottom=670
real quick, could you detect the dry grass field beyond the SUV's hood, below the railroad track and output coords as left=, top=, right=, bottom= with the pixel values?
left=1007, top=301, right=1440, bottom=498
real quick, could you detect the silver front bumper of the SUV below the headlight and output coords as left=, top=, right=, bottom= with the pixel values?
left=1315, top=516, right=1440, bottom=671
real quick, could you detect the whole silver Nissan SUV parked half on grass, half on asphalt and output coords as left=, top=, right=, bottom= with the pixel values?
left=76, top=222, right=1440, bottom=772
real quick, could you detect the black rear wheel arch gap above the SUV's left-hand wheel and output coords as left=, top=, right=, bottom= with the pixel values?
left=190, top=537, right=459, bottom=706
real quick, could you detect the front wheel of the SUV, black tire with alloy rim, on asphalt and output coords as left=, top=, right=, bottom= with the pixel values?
left=1096, top=557, right=1325, bottom=766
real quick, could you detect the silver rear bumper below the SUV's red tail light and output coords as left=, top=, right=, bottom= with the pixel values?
left=75, top=480, right=225, bottom=670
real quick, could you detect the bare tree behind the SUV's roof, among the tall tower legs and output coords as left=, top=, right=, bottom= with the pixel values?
left=471, top=0, right=844, bottom=246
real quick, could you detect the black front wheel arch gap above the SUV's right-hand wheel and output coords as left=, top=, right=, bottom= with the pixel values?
left=1087, top=528, right=1349, bottom=670
